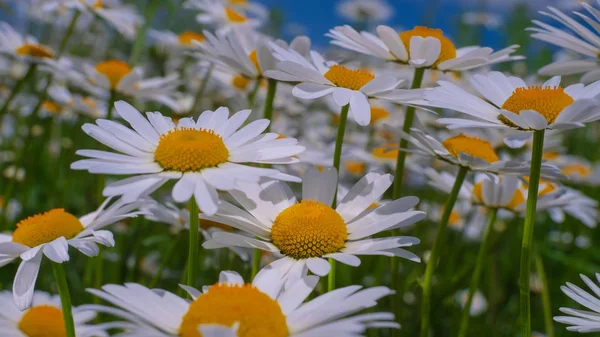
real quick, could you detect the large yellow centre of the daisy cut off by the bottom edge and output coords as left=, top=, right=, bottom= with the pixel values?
left=179, top=283, right=289, bottom=337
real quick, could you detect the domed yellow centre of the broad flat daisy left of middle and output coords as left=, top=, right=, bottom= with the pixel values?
left=154, top=127, right=229, bottom=172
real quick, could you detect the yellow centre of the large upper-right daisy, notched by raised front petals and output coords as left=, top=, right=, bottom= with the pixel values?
left=500, top=86, right=575, bottom=126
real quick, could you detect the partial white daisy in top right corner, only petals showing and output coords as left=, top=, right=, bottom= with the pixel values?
left=528, top=2, right=600, bottom=84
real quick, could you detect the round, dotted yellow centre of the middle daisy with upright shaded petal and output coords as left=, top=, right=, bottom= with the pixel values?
left=271, top=200, right=348, bottom=260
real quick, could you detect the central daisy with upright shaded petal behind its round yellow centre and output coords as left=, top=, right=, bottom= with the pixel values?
left=203, top=168, right=425, bottom=281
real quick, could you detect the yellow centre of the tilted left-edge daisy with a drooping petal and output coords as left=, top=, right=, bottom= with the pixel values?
left=12, top=208, right=83, bottom=247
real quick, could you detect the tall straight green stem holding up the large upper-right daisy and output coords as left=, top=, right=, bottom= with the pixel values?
left=519, top=130, right=544, bottom=336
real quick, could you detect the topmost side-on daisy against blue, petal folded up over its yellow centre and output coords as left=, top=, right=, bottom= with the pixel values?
left=326, top=25, right=523, bottom=72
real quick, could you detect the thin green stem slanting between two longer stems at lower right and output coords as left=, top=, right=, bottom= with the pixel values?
left=458, top=208, right=498, bottom=337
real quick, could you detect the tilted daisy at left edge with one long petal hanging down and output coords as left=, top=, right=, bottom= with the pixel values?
left=0, top=199, right=142, bottom=310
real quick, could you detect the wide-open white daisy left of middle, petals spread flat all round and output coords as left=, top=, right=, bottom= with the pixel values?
left=71, top=101, right=304, bottom=214
